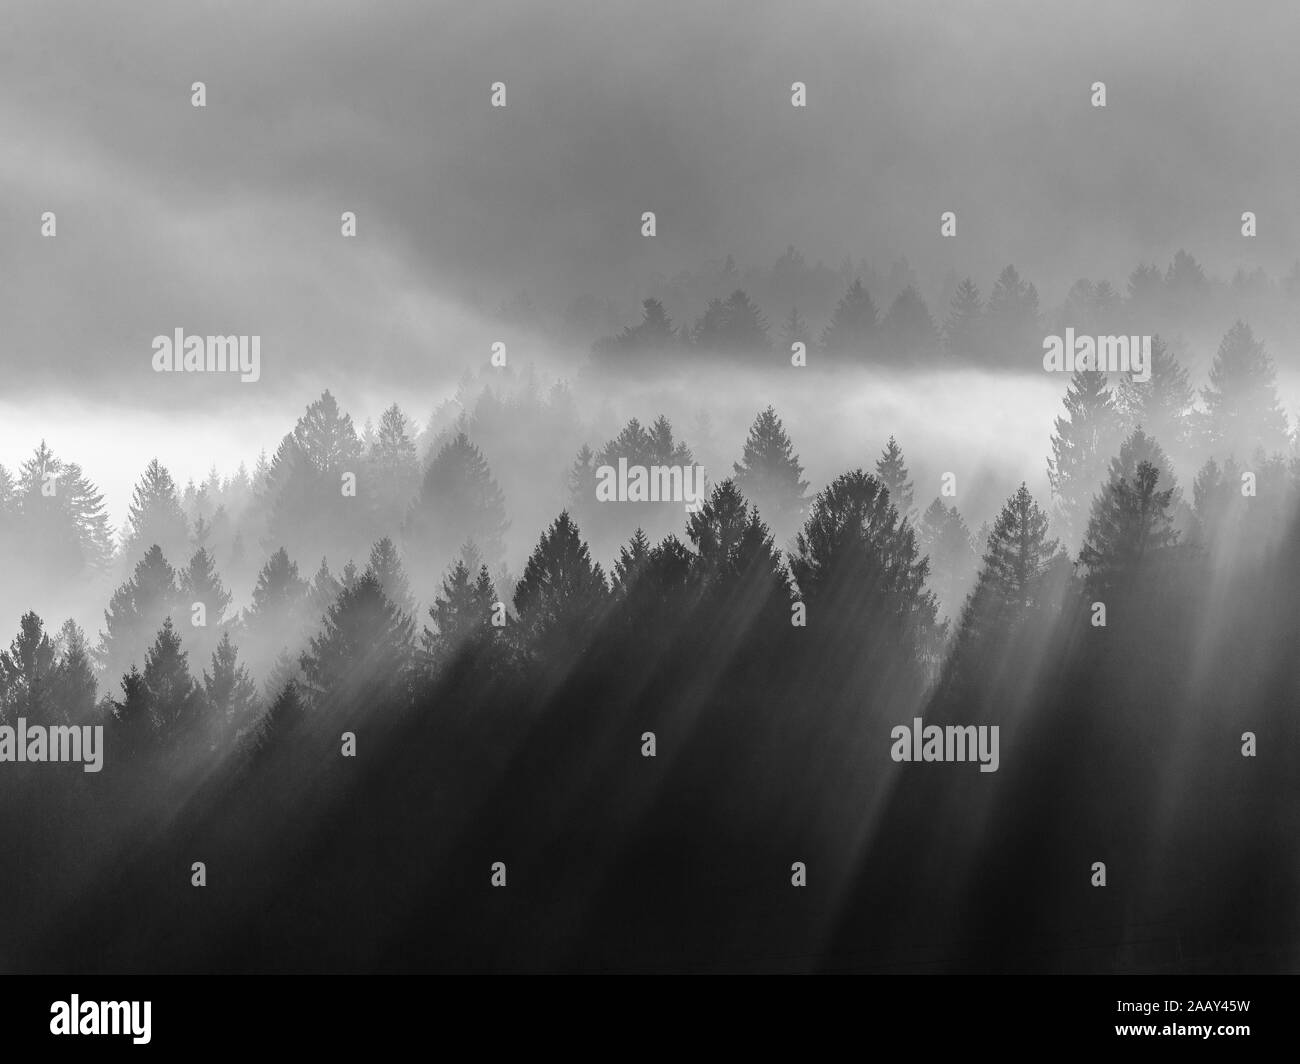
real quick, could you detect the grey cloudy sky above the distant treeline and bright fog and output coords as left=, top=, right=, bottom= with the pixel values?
left=0, top=3, right=1300, bottom=406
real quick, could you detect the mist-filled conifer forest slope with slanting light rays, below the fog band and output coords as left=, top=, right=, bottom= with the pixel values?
left=0, top=308, right=1300, bottom=972
